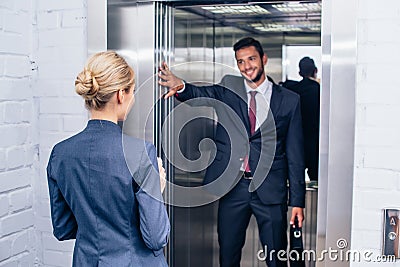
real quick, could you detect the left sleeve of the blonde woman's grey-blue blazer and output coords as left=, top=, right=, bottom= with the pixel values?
left=47, top=150, right=78, bottom=241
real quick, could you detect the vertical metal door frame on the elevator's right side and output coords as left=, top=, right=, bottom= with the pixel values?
left=317, top=0, right=357, bottom=266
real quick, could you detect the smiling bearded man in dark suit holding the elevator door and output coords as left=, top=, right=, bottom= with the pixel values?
left=159, top=38, right=305, bottom=267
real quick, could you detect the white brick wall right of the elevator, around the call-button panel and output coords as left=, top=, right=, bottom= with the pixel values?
left=351, top=0, right=400, bottom=267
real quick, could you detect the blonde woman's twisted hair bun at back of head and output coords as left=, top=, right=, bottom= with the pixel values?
left=75, top=69, right=99, bottom=100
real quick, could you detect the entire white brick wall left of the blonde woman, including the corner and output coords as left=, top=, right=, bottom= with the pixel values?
left=0, top=0, right=87, bottom=267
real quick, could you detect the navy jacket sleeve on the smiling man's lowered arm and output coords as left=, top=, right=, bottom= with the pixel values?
left=286, top=97, right=306, bottom=208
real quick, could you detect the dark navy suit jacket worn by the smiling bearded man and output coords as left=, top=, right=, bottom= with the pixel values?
left=176, top=75, right=305, bottom=207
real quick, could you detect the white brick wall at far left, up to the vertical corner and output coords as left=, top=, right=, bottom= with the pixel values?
left=0, top=0, right=38, bottom=266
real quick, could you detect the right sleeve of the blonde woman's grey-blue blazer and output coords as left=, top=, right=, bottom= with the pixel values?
left=135, top=143, right=170, bottom=256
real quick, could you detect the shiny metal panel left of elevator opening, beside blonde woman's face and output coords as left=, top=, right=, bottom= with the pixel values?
left=107, top=3, right=156, bottom=142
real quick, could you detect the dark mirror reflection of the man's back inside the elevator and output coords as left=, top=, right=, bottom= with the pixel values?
left=282, top=57, right=320, bottom=181
